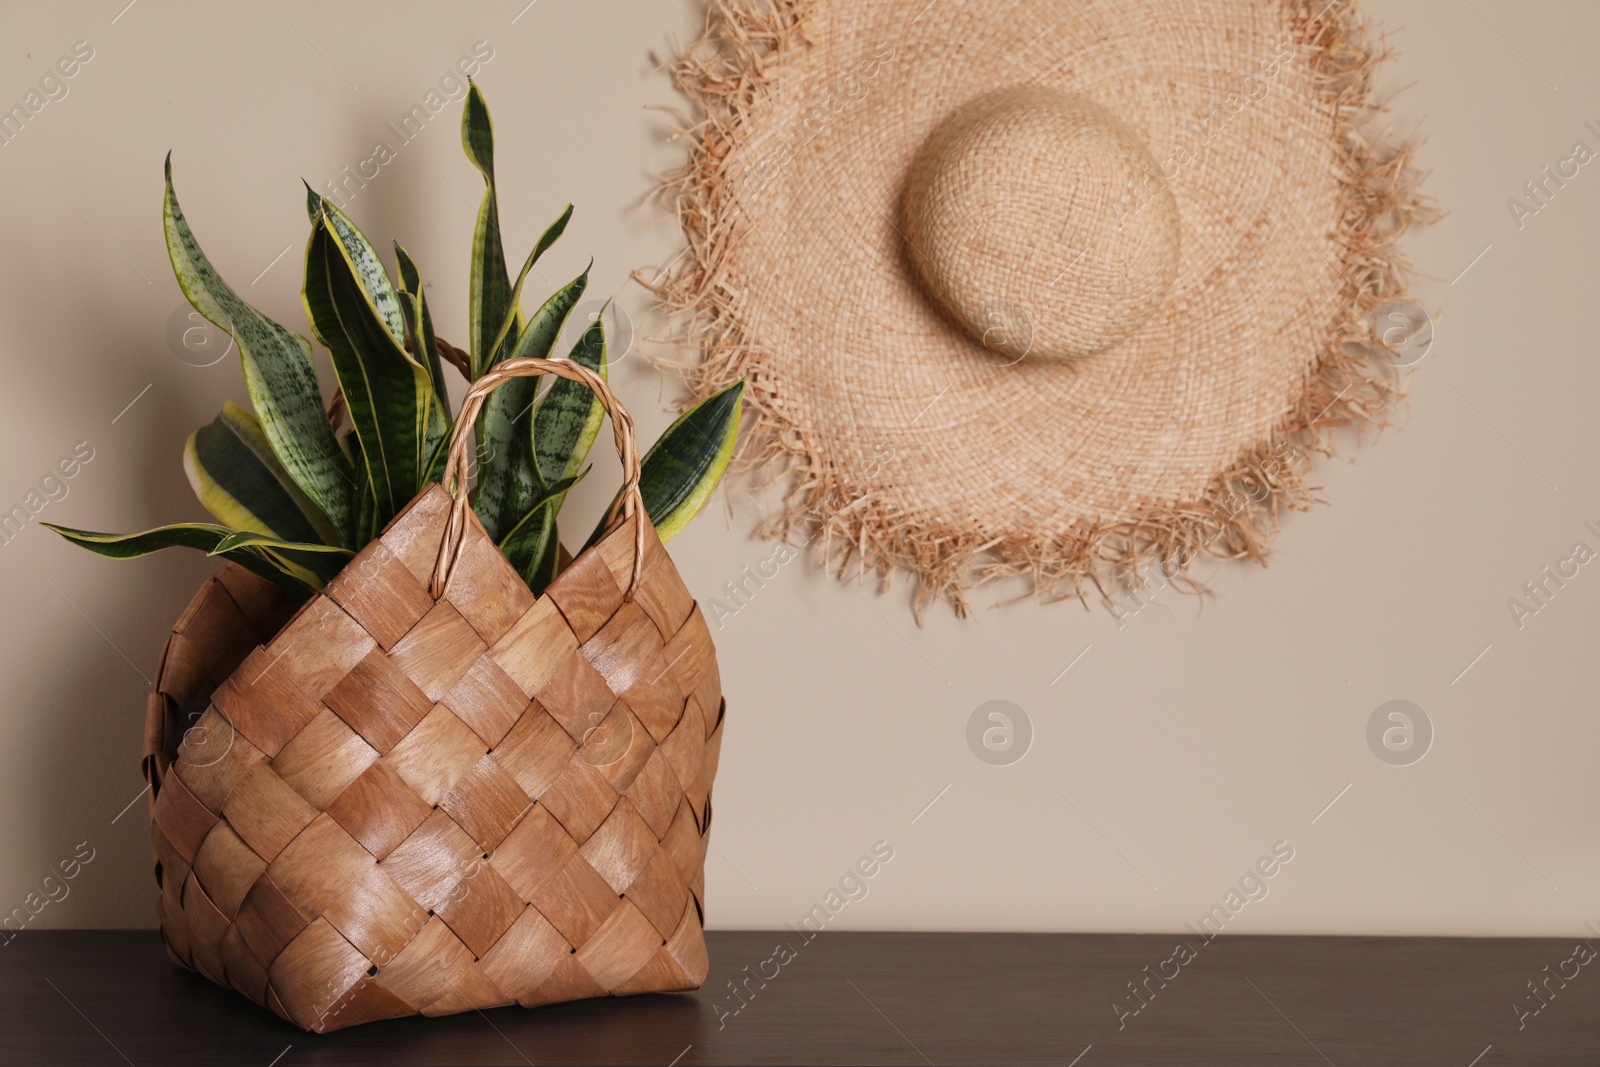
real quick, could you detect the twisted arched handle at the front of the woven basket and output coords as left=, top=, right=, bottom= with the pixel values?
left=429, top=357, right=645, bottom=600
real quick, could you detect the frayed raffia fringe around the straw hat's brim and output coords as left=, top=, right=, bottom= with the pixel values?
left=640, top=0, right=1438, bottom=622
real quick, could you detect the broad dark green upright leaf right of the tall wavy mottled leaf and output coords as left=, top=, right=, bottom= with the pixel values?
left=304, top=201, right=437, bottom=528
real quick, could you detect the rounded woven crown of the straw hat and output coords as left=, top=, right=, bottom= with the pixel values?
left=904, top=86, right=1179, bottom=363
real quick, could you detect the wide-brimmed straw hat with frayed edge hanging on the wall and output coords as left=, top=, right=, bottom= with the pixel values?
left=656, top=0, right=1427, bottom=609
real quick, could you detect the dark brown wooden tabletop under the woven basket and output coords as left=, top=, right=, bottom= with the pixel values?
left=0, top=931, right=1600, bottom=1067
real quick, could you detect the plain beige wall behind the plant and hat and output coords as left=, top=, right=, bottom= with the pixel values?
left=0, top=0, right=1600, bottom=936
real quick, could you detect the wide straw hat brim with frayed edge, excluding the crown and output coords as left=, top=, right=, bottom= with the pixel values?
left=638, top=0, right=1435, bottom=614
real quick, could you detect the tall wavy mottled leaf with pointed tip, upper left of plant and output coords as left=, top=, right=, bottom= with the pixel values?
left=162, top=154, right=357, bottom=544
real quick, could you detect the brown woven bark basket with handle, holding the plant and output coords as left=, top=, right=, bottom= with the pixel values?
left=144, top=360, right=725, bottom=1032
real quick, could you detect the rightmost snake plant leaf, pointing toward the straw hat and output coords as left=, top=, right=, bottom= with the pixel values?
left=589, top=379, right=744, bottom=544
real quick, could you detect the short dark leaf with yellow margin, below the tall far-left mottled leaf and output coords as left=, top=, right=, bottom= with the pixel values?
left=184, top=403, right=341, bottom=544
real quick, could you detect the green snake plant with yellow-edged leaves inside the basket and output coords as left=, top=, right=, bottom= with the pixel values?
left=50, top=85, right=744, bottom=600
